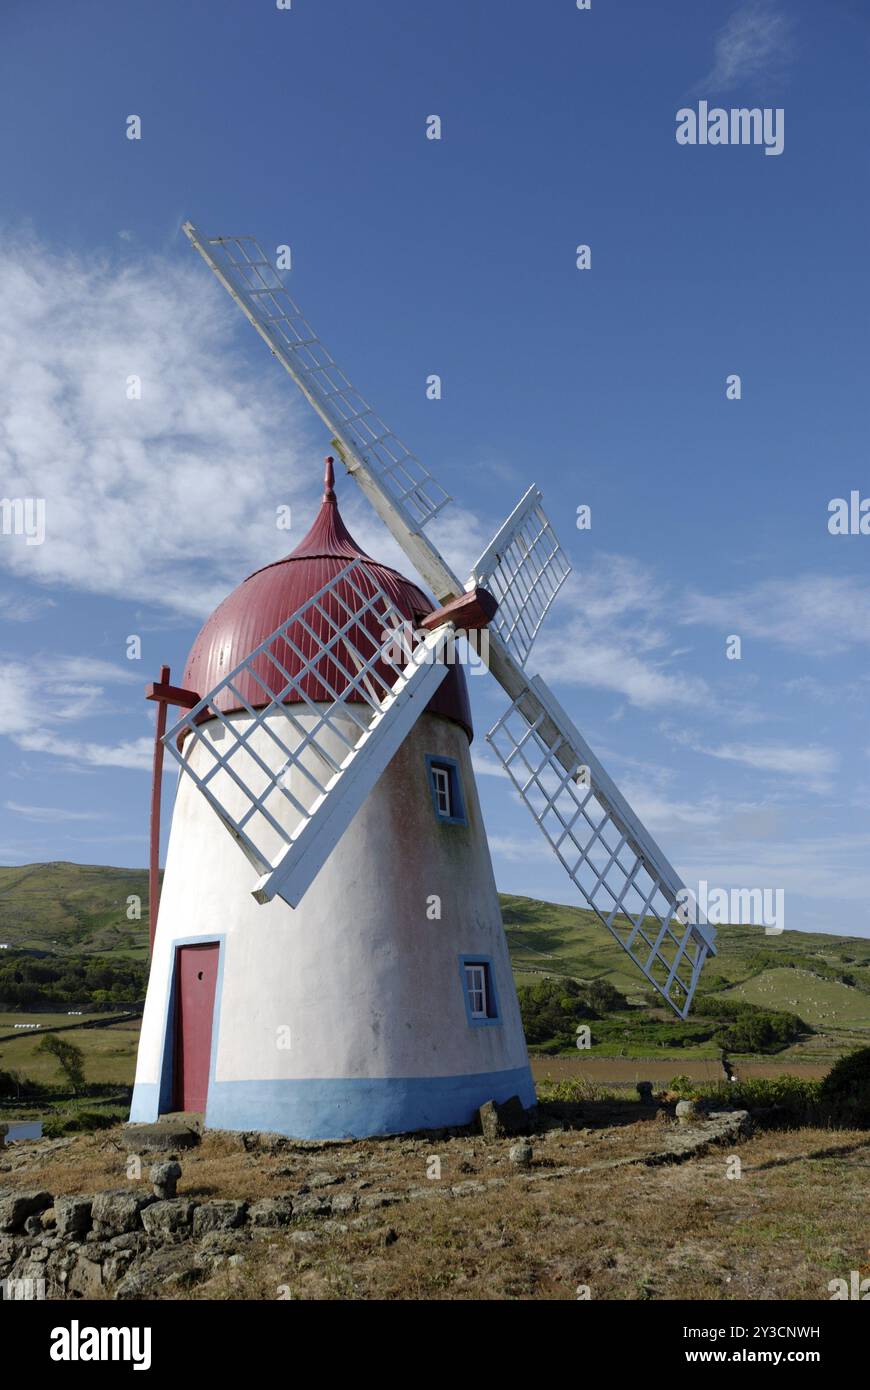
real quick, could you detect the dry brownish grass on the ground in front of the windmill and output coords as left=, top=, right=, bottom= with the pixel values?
left=0, top=1119, right=870, bottom=1300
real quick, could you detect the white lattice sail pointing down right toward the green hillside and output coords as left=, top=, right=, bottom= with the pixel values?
left=486, top=677, right=716, bottom=1017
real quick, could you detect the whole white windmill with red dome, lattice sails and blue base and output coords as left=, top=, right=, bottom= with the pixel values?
left=131, top=222, right=714, bottom=1138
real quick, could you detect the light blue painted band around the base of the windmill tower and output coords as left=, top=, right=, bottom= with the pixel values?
left=131, top=1066, right=535, bottom=1138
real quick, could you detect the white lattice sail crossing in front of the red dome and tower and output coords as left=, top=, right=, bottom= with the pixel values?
left=164, top=560, right=453, bottom=906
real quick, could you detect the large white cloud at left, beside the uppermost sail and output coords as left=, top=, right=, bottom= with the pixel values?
left=0, top=242, right=320, bottom=617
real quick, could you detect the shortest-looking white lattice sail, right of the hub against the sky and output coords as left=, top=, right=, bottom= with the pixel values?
left=470, top=487, right=571, bottom=666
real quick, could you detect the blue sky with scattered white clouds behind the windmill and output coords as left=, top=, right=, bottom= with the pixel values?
left=0, top=0, right=870, bottom=935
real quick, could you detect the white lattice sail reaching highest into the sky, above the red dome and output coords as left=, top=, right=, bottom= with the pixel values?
left=183, top=222, right=450, bottom=531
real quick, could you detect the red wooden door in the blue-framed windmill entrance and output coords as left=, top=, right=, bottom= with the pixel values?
left=172, top=941, right=220, bottom=1112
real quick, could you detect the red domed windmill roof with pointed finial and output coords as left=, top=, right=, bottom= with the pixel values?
left=183, top=459, right=473, bottom=738
